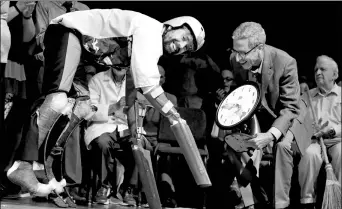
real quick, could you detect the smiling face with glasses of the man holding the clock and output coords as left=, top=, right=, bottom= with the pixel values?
left=233, top=39, right=261, bottom=70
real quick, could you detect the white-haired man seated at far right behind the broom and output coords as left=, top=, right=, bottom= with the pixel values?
left=299, top=55, right=341, bottom=208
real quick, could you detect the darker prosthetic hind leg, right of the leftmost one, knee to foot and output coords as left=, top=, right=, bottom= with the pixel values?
left=44, top=97, right=96, bottom=208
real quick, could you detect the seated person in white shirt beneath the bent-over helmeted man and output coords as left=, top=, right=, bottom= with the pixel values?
left=85, top=68, right=137, bottom=205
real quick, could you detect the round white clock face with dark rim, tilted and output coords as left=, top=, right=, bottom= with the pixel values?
left=216, top=84, right=260, bottom=128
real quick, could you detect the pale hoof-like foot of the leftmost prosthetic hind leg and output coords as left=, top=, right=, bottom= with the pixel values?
left=7, top=161, right=53, bottom=197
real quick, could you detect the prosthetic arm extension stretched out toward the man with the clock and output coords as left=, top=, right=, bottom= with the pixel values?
left=144, top=86, right=211, bottom=187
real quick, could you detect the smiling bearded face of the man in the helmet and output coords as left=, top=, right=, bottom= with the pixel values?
left=163, top=26, right=194, bottom=55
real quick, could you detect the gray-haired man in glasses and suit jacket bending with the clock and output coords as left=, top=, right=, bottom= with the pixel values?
left=226, top=22, right=312, bottom=208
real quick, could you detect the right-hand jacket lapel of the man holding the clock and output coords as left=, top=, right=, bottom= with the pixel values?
left=261, top=45, right=274, bottom=97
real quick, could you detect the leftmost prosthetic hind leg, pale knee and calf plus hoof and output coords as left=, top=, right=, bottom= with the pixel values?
left=7, top=92, right=67, bottom=196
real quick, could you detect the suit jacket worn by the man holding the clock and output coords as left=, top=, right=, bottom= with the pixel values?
left=230, top=45, right=311, bottom=153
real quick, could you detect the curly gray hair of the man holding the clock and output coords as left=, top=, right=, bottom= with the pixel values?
left=232, top=22, right=266, bottom=48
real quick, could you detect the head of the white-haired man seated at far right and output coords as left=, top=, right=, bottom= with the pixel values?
left=315, top=58, right=337, bottom=88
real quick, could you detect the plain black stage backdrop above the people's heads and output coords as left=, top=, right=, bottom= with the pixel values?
left=83, top=1, right=342, bottom=84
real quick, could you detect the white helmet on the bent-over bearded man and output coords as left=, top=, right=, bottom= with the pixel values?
left=164, top=16, right=205, bottom=51
